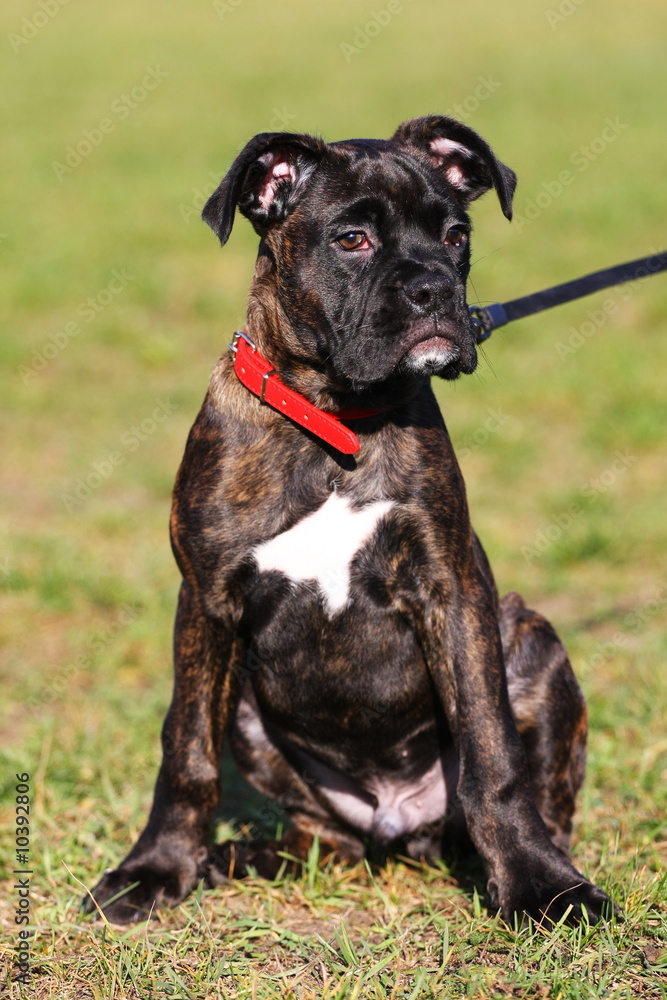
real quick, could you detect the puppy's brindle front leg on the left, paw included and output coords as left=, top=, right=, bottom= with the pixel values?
left=84, top=584, right=242, bottom=923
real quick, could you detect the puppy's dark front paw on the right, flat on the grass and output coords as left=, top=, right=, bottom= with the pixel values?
left=488, top=859, right=620, bottom=926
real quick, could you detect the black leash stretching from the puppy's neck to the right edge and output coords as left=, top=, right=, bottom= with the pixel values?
left=470, top=253, right=667, bottom=344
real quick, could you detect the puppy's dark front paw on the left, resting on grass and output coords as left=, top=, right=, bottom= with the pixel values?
left=81, top=861, right=197, bottom=924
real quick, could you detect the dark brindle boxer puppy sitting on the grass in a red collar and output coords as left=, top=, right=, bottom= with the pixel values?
left=88, top=116, right=609, bottom=922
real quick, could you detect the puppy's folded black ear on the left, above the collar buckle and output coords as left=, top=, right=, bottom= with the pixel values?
left=202, top=132, right=326, bottom=246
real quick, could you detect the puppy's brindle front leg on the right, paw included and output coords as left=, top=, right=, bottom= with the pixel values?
left=418, top=568, right=611, bottom=921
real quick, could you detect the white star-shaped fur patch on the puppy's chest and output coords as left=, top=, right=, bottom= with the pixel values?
left=253, top=493, right=394, bottom=614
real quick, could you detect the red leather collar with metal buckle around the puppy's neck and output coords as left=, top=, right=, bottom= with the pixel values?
left=229, top=330, right=382, bottom=455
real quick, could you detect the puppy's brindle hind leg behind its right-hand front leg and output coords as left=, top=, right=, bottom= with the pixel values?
left=500, top=593, right=587, bottom=856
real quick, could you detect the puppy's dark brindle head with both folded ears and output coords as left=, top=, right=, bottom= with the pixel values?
left=203, top=115, right=516, bottom=392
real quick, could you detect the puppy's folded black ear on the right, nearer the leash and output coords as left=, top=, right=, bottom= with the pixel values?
left=391, top=115, right=516, bottom=219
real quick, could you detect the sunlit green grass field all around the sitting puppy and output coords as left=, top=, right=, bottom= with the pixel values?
left=0, top=0, right=667, bottom=1000
